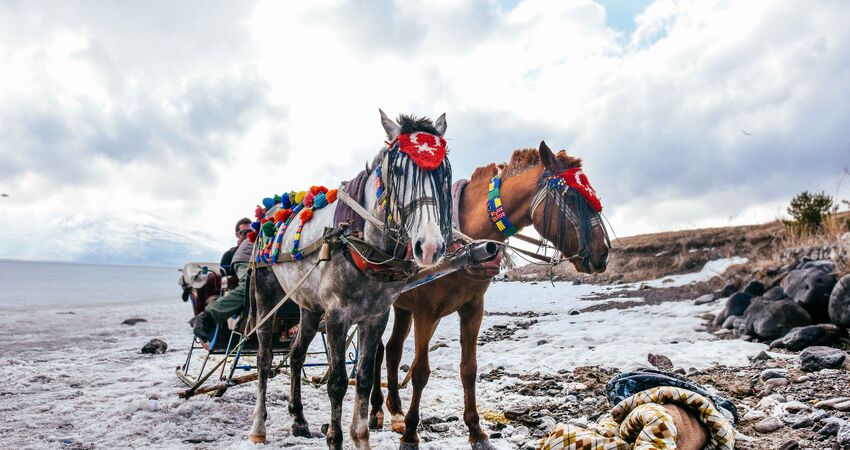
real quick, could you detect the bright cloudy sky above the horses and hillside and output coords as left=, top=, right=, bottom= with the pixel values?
left=0, top=0, right=850, bottom=262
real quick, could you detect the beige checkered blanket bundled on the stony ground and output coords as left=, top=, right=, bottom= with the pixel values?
left=537, top=386, right=735, bottom=450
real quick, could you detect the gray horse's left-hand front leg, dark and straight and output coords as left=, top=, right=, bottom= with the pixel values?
left=325, top=311, right=351, bottom=450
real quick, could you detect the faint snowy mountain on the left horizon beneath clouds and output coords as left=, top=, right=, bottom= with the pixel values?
left=0, top=210, right=222, bottom=267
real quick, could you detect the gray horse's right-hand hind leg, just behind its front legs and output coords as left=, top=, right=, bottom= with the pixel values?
left=289, top=308, right=322, bottom=437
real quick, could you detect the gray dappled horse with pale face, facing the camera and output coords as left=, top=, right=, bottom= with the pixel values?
left=249, top=111, right=451, bottom=449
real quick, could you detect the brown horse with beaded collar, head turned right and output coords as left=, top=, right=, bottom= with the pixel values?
left=370, top=142, right=610, bottom=450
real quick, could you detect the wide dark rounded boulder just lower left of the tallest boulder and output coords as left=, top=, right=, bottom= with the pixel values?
left=744, top=298, right=812, bottom=340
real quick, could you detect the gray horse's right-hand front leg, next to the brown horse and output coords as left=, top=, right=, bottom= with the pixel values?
left=350, top=311, right=390, bottom=450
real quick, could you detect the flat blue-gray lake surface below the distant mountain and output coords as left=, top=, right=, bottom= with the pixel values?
left=0, top=260, right=180, bottom=311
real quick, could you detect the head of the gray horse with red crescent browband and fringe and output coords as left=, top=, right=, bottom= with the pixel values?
left=372, top=111, right=452, bottom=267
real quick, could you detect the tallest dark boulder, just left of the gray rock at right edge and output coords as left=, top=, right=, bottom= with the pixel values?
left=781, top=261, right=836, bottom=322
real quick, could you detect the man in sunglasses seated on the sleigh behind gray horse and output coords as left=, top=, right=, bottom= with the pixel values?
left=192, top=219, right=254, bottom=341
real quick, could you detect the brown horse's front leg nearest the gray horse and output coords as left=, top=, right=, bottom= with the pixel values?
left=399, top=316, right=440, bottom=450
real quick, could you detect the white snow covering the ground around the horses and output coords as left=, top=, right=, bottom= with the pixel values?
left=0, top=260, right=765, bottom=450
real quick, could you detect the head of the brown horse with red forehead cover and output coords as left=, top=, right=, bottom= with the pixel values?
left=531, top=141, right=611, bottom=273
